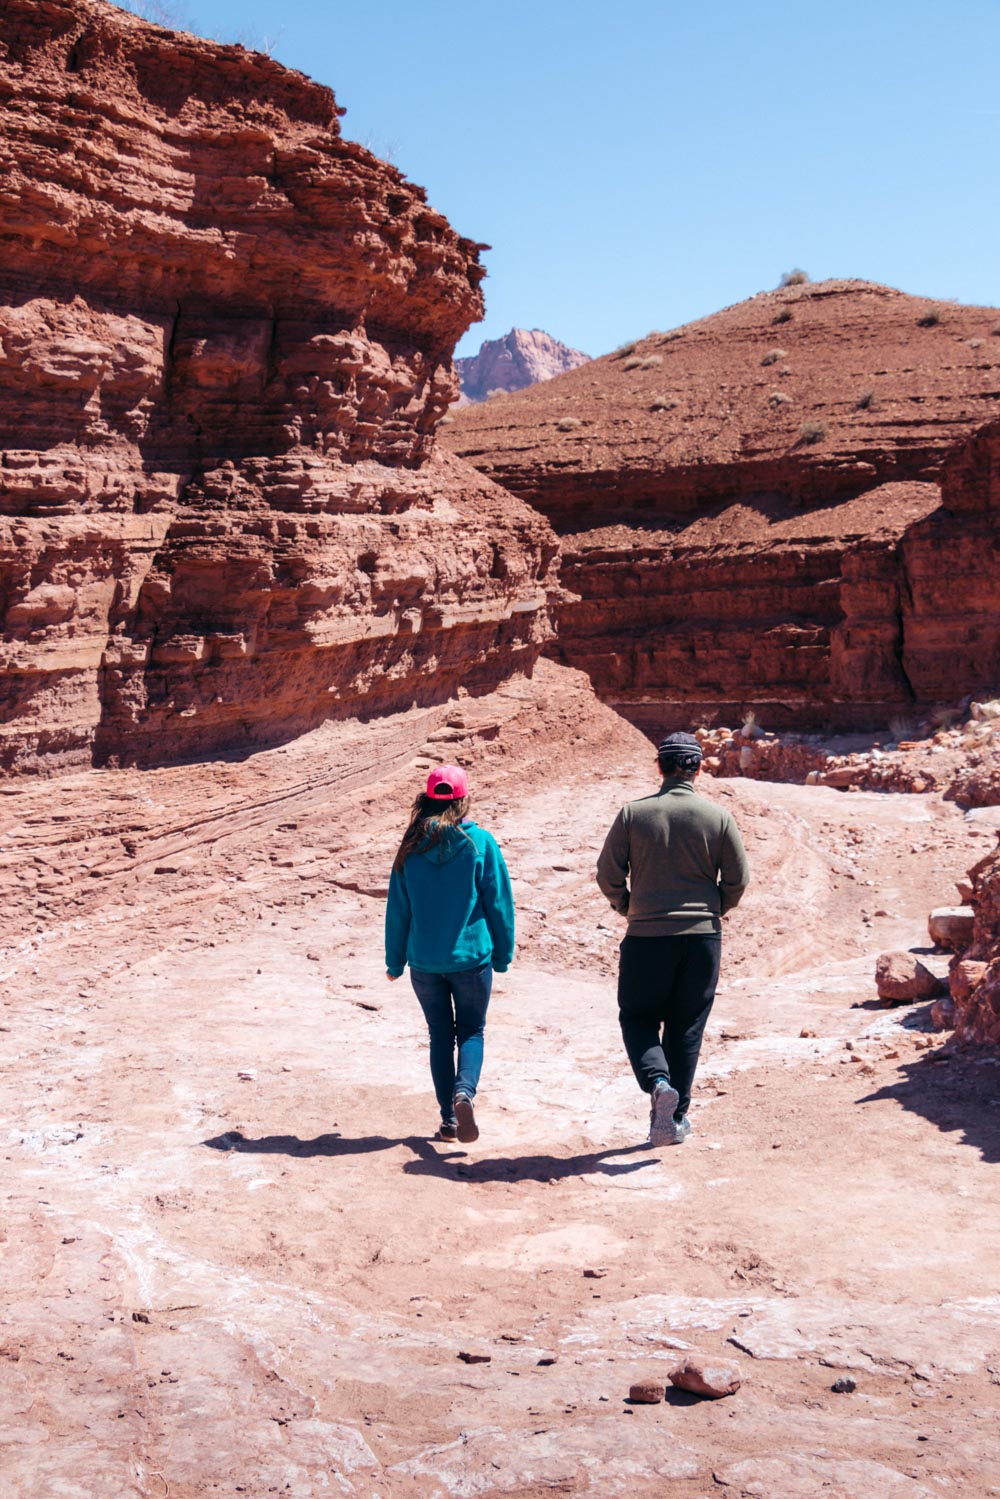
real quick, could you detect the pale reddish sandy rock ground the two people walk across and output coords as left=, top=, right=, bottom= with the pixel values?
left=0, top=669, right=1000, bottom=1499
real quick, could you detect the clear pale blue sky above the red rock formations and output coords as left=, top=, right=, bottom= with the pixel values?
left=144, top=0, right=1000, bottom=354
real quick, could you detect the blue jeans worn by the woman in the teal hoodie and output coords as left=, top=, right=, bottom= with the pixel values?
left=409, top=962, right=493, bottom=1121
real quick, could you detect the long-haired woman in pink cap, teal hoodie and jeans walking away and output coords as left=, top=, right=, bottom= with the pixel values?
left=385, top=764, right=514, bottom=1145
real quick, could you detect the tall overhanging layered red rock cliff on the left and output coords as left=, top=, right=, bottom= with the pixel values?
left=0, top=0, right=556, bottom=769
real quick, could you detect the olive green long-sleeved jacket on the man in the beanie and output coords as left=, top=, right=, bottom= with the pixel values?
left=597, top=778, right=750, bottom=937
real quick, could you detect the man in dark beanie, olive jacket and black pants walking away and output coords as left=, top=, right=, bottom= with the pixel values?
left=597, top=733, right=750, bottom=1145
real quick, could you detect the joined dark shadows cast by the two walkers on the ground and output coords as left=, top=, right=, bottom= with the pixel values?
left=202, top=1130, right=660, bottom=1181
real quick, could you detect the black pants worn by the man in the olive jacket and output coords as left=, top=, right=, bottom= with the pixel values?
left=618, top=932, right=723, bottom=1120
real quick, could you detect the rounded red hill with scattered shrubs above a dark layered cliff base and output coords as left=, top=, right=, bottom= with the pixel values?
left=445, top=282, right=1000, bottom=732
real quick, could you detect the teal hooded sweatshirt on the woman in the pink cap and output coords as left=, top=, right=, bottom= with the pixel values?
left=385, top=820, right=514, bottom=979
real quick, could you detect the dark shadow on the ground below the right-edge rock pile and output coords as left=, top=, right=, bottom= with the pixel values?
left=858, top=1049, right=1000, bottom=1163
